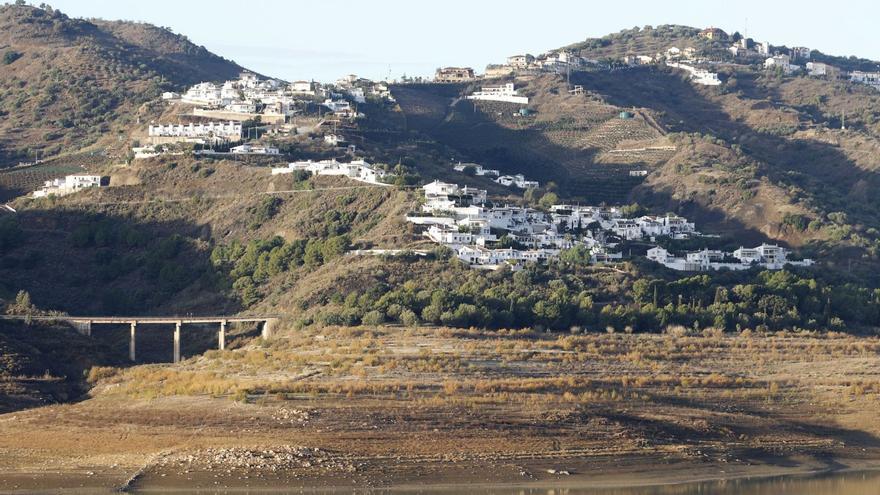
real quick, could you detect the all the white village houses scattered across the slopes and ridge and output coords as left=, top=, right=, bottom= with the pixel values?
left=27, top=28, right=828, bottom=271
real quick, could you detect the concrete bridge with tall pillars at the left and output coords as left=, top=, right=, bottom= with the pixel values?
left=0, top=315, right=278, bottom=363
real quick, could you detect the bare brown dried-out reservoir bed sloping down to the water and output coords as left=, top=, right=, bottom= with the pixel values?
left=0, top=327, right=880, bottom=490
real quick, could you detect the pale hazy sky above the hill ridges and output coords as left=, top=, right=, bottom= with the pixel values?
left=48, top=0, right=880, bottom=81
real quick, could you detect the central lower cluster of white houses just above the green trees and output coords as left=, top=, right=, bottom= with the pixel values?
left=406, top=180, right=813, bottom=271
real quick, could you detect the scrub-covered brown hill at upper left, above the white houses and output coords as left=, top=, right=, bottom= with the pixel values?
left=0, top=5, right=241, bottom=168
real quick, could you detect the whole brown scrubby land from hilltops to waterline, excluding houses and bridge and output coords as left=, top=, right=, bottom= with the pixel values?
left=0, top=17, right=880, bottom=493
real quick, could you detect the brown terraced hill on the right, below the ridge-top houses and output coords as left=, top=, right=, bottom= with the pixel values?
left=394, top=51, right=880, bottom=280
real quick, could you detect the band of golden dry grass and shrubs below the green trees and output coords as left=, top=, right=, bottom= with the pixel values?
left=89, top=327, right=880, bottom=414
